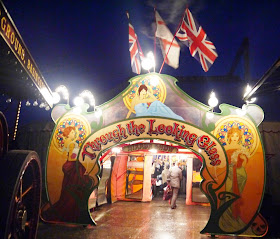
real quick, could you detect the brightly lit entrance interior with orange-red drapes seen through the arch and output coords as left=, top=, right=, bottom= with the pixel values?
left=89, top=139, right=209, bottom=210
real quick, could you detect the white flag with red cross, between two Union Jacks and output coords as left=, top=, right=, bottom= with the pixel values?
left=155, top=11, right=180, bottom=69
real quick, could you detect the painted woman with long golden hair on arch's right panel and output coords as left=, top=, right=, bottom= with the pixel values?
left=220, top=126, right=250, bottom=232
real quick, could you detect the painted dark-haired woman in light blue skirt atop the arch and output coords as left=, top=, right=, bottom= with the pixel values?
left=126, top=85, right=184, bottom=121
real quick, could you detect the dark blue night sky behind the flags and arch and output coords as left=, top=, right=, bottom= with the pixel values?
left=3, top=0, right=280, bottom=125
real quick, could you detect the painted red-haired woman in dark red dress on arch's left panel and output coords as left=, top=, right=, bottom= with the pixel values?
left=42, top=126, right=92, bottom=223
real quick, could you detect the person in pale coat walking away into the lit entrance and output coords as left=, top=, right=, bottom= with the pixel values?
left=168, top=163, right=183, bottom=209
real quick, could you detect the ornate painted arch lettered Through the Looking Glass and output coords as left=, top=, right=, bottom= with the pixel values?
left=41, top=74, right=267, bottom=237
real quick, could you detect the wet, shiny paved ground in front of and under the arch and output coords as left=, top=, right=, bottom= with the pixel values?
left=37, top=197, right=277, bottom=239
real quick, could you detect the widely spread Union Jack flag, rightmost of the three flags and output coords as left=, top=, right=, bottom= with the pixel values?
left=176, top=8, right=218, bottom=72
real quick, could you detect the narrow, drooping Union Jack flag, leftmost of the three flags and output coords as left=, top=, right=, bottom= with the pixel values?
left=128, top=23, right=141, bottom=74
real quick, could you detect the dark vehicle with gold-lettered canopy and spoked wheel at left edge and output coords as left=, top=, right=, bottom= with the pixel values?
left=0, top=1, right=52, bottom=239
